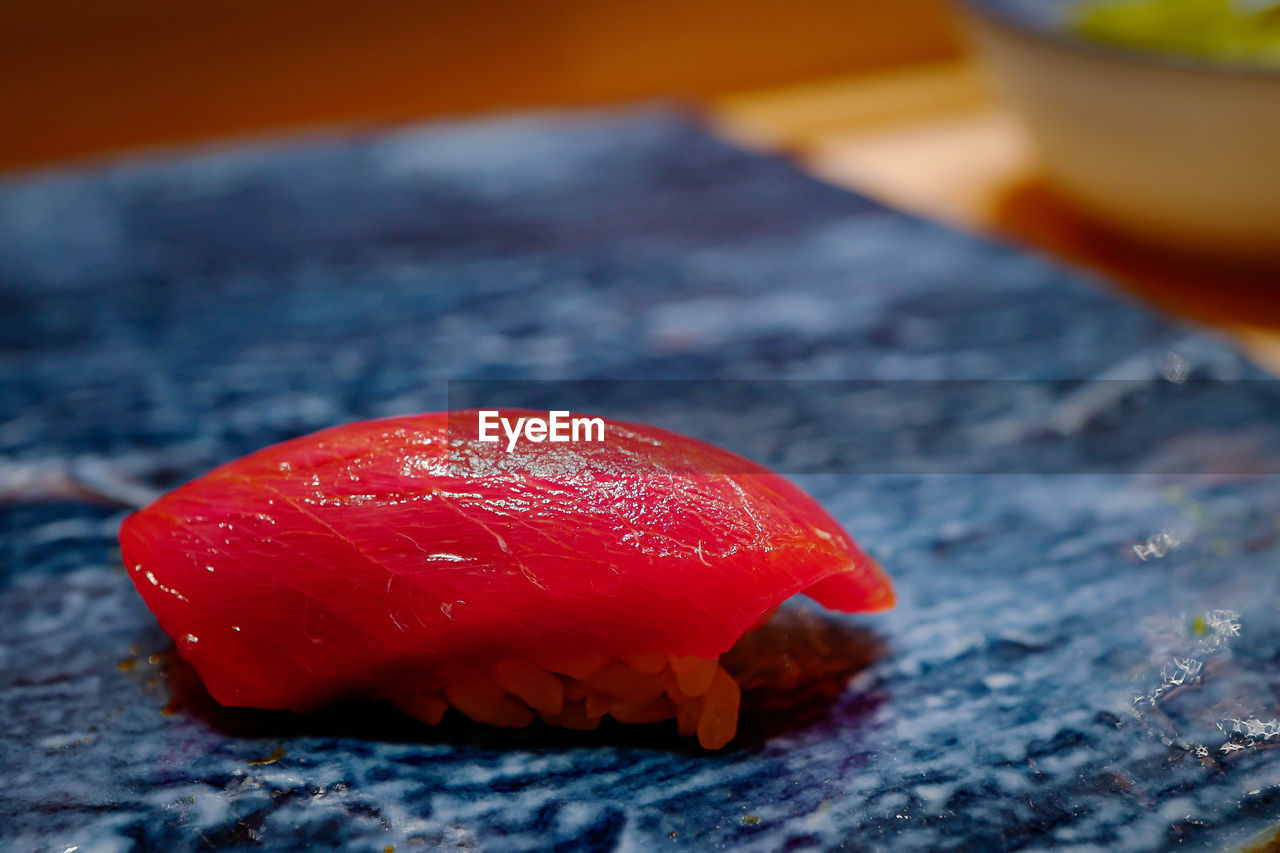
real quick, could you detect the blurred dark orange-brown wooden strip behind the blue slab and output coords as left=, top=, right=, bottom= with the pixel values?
left=0, top=0, right=959, bottom=169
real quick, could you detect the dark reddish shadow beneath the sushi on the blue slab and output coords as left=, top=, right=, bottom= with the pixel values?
left=164, top=605, right=886, bottom=757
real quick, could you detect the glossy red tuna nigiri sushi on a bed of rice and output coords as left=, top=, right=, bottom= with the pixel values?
left=120, top=410, right=893, bottom=749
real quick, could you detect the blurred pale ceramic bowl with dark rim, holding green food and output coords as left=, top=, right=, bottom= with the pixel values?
left=961, top=0, right=1280, bottom=260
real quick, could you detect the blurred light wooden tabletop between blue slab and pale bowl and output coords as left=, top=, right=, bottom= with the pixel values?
left=710, top=61, right=1280, bottom=371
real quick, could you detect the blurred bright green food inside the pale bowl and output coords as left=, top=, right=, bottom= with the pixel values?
left=1071, top=0, right=1280, bottom=68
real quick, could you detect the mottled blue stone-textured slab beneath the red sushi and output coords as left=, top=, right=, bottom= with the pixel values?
left=0, top=113, right=1280, bottom=852
